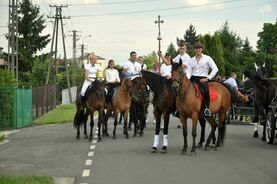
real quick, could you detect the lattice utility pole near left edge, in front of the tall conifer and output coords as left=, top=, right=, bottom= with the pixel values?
left=8, top=0, right=19, bottom=81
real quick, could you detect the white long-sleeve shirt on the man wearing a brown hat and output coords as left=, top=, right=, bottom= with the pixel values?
left=187, top=54, right=218, bottom=80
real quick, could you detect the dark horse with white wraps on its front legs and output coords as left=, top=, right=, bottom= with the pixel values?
left=141, top=71, right=176, bottom=153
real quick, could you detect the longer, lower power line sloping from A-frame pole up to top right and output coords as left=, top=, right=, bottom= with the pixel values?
left=71, top=0, right=244, bottom=17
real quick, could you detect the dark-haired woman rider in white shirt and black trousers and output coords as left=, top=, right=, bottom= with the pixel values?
left=105, top=59, right=120, bottom=107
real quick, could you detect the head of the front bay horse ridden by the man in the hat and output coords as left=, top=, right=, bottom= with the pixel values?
left=171, top=62, right=184, bottom=94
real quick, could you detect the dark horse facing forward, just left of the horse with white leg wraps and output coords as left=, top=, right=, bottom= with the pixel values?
left=129, top=77, right=149, bottom=137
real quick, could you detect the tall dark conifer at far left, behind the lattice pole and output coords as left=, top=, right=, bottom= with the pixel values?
left=18, top=0, right=50, bottom=75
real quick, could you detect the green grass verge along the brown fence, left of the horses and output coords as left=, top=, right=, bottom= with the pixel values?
left=34, top=104, right=76, bottom=125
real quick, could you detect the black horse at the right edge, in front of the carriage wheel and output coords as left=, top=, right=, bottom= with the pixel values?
left=244, top=70, right=277, bottom=141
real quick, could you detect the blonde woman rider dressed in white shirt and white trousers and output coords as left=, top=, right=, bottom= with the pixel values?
left=81, top=53, right=100, bottom=103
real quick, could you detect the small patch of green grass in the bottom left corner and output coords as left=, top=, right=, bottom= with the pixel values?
left=0, top=176, right=54, bottom=184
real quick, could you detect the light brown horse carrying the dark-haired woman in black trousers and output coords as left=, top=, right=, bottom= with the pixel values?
left=103, top=79, right=132, bottom=139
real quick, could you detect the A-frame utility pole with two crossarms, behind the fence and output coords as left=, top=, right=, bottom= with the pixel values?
left=45, top=5, right=72, bottom=106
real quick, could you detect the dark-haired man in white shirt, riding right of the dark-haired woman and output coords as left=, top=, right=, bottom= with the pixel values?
left=122, top=51, right=141, bottom=77
